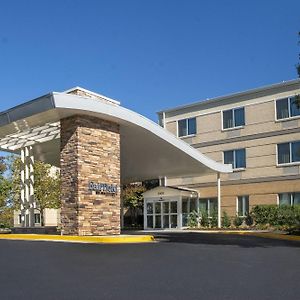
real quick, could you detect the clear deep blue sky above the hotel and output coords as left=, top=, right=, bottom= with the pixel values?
left=0, top=0, right=300, bottom=121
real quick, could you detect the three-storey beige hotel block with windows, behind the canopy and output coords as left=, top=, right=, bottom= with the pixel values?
left=158, top=79, right=300, bottom=221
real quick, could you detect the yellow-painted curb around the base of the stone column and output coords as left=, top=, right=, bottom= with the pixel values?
left=0, top=234, right=155, bottom=244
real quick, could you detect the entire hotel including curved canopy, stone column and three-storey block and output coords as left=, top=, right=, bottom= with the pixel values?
left=0, top=79, right=300, bottom=235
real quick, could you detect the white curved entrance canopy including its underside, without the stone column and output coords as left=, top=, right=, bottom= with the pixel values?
left=0, top=92, right=232, bottom=183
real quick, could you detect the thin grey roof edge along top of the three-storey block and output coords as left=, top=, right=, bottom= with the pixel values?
left=156, top=78, right=300, bottom=115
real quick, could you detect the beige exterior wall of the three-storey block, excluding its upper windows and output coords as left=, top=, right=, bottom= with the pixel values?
left=165, top=81, right=300, bottom=215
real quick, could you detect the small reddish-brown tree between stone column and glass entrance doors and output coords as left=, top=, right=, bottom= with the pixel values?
left=122, top=184, right=146, bottom=224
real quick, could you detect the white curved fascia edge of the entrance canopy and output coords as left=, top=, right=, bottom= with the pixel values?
left=0, top=92, right=232, bottom=173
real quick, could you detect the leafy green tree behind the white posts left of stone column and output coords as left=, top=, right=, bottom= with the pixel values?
left=11, top=158, right=61, bottom=226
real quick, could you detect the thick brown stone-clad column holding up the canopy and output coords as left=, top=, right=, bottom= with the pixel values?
left=60, top=115, right=120, bottom=235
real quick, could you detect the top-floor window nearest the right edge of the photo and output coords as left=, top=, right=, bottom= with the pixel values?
left=276, top=96, right=300, bottom=120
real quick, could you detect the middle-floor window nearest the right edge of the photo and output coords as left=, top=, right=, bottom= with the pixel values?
left=277, top=141, right=300, bottom=165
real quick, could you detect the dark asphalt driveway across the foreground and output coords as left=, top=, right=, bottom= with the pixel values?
left=0, top=233, right=300, bottom=300
